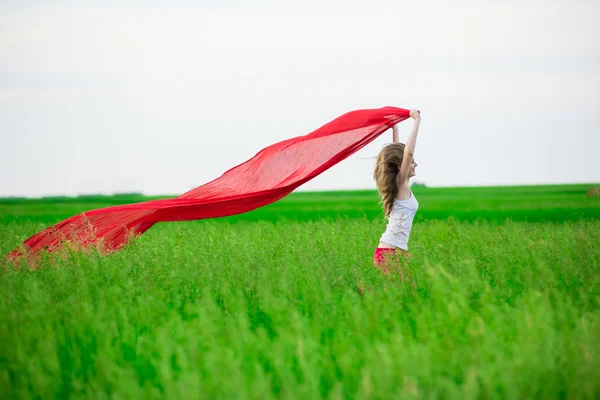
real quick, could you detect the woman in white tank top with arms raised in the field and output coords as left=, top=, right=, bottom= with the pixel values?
left=373, top=110, right=421, bottom=272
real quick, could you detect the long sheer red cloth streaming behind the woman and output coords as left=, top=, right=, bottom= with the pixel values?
left=7, top=107, right=410, bottom=260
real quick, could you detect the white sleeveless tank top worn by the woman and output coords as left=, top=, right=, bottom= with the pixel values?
left=380, top=190, right=419, bottom=250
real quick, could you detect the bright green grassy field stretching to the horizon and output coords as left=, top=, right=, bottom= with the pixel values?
left=0, top=185, right=600, bottom=399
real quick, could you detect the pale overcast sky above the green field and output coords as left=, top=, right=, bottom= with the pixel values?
left=0, top=0, right=600, bottom=196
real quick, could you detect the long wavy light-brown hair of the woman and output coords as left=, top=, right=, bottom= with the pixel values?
left=373, top=143, right=404, bottom=217
